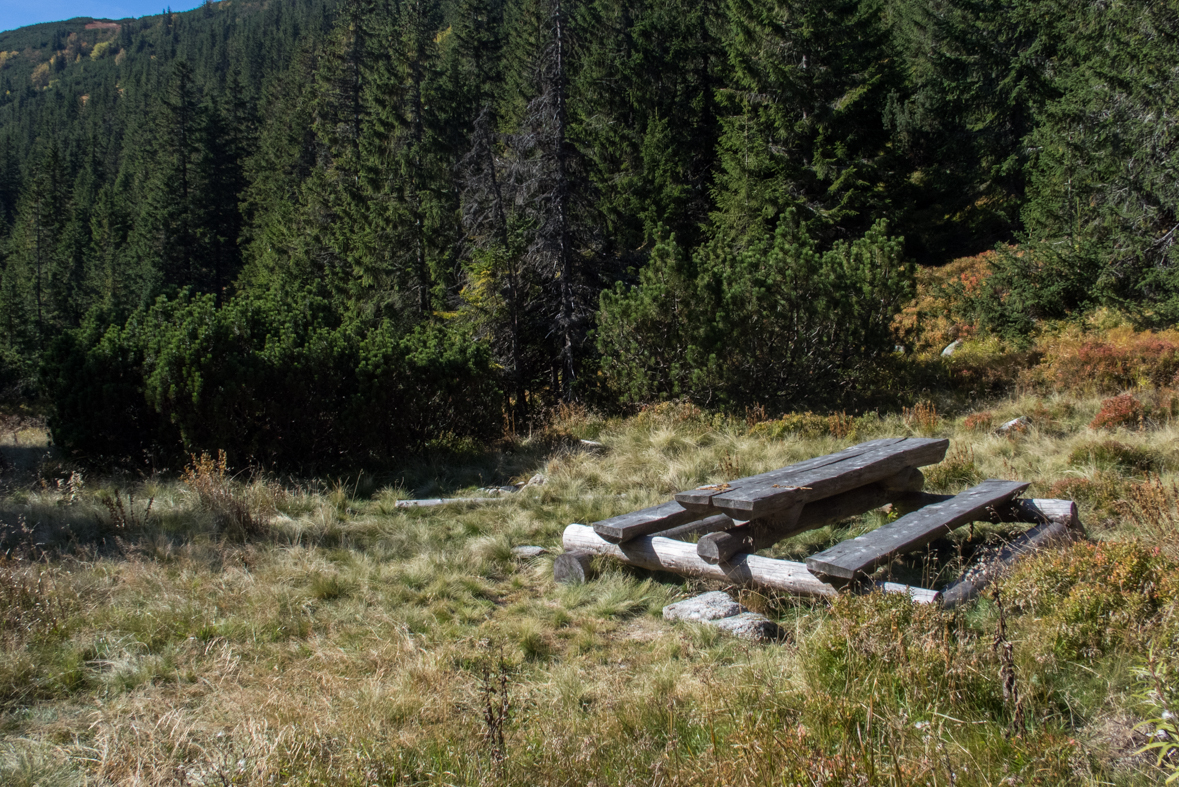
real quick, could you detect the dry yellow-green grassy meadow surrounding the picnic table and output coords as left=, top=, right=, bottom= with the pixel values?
left=0, top=396, right=1179, bottom=785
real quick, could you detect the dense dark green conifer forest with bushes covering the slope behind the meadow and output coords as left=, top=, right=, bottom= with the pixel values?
left=0, top=0, right=1179, bottom=471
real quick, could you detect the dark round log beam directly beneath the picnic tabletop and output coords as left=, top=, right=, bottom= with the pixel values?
left=696, top=468, right=926, bottom=563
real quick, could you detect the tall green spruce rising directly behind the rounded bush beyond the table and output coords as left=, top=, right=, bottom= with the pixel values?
left=714, top=0, right=904, bottom=240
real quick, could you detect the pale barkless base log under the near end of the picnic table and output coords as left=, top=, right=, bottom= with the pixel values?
left=562, top=524, right=937, bottom=603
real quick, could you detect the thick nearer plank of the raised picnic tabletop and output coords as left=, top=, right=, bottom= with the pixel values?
left=677, top=437, right=949, bottom=520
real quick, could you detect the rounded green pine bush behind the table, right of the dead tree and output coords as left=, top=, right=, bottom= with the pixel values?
left=597, top=212, right=914, bottom=409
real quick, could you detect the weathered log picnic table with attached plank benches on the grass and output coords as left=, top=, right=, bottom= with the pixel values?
left=565, top=437, right=1084, bottom=606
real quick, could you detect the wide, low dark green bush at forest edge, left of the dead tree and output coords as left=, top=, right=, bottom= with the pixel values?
left=47, top=291, right=500, bottom=470
